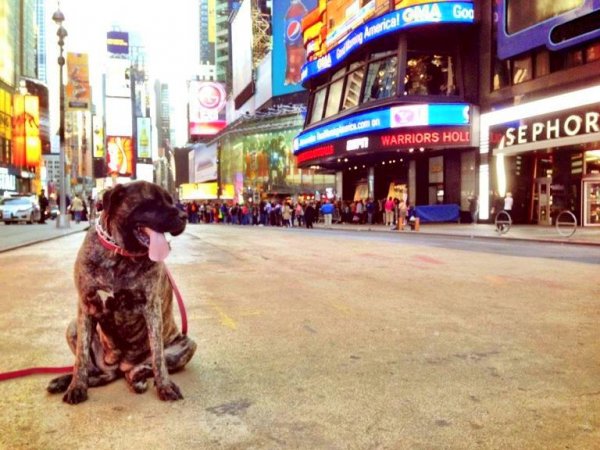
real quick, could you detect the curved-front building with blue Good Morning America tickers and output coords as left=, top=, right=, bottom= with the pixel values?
left=296, top=0, right=480, bottom=220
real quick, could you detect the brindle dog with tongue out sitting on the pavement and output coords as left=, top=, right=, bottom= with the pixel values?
left=48, top=181, right=196, bottom=404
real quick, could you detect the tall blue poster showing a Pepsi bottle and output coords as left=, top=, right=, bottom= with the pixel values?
left=271, top=0, right=318, bottom=96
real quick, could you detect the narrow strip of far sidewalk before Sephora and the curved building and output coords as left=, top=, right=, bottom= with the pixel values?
left=315, top=219, right=600, bottom=245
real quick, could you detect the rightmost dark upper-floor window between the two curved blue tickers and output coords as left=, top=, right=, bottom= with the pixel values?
left=404, top=52, right=458, bottom=95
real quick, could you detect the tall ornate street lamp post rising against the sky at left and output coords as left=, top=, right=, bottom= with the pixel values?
left=52, top=2, right=69, bottom=228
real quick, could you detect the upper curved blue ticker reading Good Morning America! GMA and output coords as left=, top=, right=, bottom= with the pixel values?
left=301, top=2, right=475, bottom=83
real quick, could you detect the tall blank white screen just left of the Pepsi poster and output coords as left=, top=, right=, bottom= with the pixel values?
left=231, top=0, right=253, bottom=97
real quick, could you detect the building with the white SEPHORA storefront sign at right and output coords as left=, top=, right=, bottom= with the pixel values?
left=479, top=0, right=600, bottom=226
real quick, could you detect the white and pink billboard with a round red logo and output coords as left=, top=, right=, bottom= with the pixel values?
left=189, top=81, right=227, bottom=136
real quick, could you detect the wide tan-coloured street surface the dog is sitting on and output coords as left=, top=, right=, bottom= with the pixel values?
left=0, top=225, right=600, bottom=449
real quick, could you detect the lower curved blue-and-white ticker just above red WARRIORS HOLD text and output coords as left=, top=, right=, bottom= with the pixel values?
left=294, top=103, right=471, bottom=154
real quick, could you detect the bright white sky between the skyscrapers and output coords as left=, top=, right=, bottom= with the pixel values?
left=46, top=0, right=199, bottom=146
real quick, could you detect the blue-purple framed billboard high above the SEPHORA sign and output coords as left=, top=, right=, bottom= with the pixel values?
left=497, top=0, right=600, bottom=59
